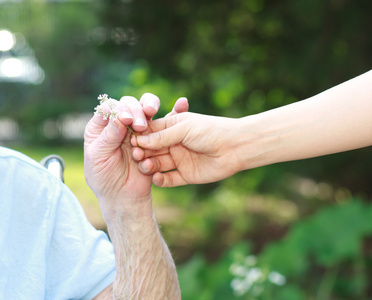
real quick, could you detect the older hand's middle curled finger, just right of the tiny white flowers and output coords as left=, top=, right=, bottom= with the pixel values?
left=118, top=96, right=147, bottom=132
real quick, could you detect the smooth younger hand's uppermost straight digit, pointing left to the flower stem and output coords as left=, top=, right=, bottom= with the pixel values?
left=137, top=124, right=187, bottom=150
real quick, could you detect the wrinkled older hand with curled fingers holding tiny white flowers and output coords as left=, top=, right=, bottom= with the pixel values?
left=84, top=94, right=160, bottom=209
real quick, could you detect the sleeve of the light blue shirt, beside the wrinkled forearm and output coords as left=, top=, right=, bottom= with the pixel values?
left=46, top=176, right=115, bottom=299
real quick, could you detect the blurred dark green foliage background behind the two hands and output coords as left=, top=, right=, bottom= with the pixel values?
left=0, top=0, right=372, bottom=300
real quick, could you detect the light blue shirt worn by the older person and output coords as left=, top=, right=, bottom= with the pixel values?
left=0, top=147, right=115, bottom=300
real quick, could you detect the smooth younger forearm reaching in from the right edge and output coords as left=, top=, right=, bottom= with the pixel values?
left=241, top=71, right=372, bottom=169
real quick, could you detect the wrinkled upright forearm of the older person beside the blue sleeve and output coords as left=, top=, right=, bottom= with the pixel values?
left=101, top=198, right=181, bottom=299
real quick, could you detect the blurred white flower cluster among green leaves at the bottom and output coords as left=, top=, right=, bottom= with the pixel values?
left=230, top=255, right=286, bottom=296
